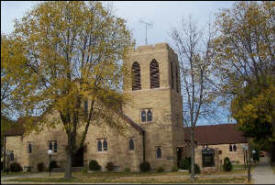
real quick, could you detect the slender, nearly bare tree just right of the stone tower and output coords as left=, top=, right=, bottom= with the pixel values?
left=171, top=18, right=217, bottom=181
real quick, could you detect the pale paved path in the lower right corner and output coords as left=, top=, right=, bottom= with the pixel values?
left=252, top=157, right=275, bottom=184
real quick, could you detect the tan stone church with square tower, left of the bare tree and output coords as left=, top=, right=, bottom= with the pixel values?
left=5, top=43, right=190, bottom=171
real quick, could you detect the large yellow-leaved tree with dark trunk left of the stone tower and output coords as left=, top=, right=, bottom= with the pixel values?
left=4, top=1, right=133, bottom=178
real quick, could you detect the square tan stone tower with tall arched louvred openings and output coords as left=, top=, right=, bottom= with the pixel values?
left=123, top=43, right=184, bottom=168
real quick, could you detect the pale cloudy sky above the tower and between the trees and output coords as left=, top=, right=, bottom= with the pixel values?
left=1, top=1, right=234, bottom=124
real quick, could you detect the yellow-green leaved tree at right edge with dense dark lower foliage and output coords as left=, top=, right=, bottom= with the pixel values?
left=214, top=2, right=275, bottom=147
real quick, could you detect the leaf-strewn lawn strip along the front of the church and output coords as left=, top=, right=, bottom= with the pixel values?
left=5, top=172, right=246, bottom=183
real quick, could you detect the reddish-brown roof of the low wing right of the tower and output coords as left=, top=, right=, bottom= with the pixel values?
left=185, top=124, right=247, bottom=145
